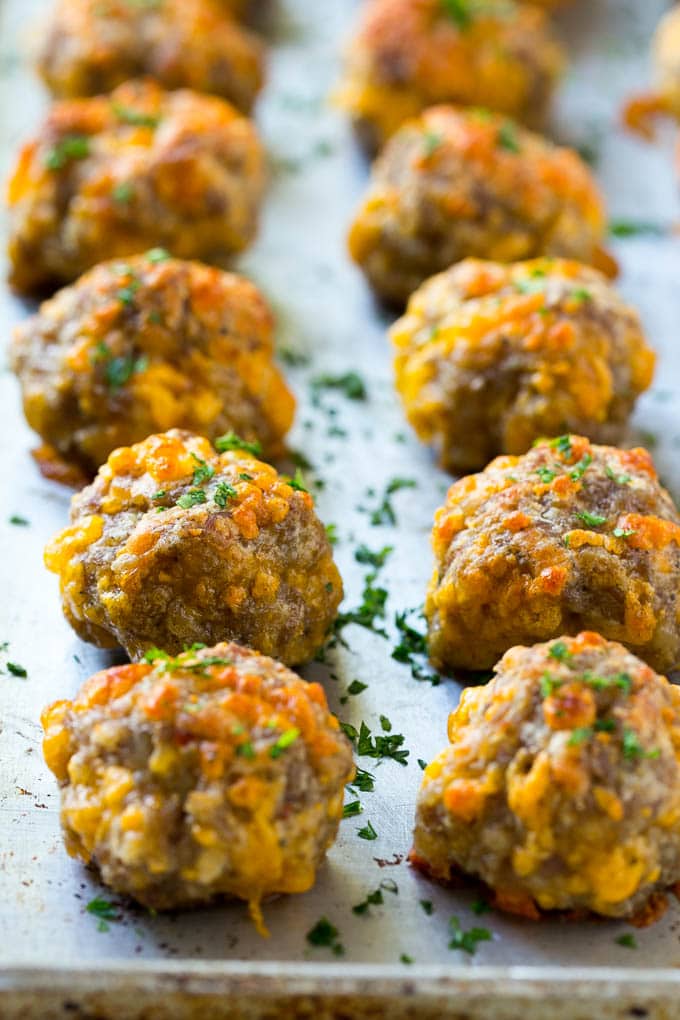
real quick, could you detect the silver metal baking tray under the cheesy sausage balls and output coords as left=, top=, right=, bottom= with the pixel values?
left=0, top=0, right=680, bottom=1020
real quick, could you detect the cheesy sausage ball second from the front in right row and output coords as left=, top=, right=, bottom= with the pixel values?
left=425, top=436, right=680, bottom=671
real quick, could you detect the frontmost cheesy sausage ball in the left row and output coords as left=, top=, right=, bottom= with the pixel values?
left=43, top=644, right=354, bottom=927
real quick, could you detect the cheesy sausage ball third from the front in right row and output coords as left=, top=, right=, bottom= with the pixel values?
left=391, top=259, right=655, bottom=472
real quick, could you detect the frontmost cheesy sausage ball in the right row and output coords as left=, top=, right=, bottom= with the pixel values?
left=414, top=632, right=680, bottom=924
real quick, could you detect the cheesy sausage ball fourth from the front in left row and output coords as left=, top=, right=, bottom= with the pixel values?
left=8, top=81, right=265, bottom=293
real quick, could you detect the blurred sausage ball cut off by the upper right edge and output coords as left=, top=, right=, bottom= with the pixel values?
left=624, top=5, right=680, bottom=139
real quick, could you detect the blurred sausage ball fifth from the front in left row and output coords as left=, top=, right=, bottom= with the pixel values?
left=38, top=0, right=264, bottom=112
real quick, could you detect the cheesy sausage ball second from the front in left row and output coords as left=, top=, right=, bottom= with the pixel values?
left=46, top=429, right=343, bottom=664
